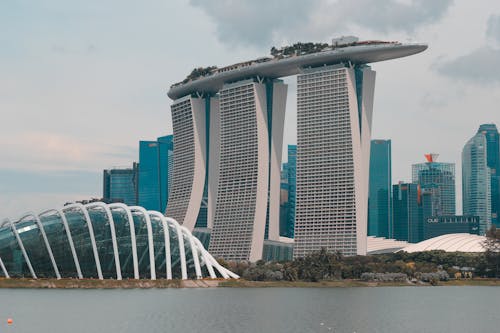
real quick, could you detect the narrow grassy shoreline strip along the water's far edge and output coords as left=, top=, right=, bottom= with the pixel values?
left=0, top=278, right=500, bottom=289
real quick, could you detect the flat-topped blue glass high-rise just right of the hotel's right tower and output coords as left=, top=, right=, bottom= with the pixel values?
left=368, top=140, right=393, bottom=238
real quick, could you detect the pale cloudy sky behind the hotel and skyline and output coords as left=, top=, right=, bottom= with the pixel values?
left=0, top=0, right=500, bottom=219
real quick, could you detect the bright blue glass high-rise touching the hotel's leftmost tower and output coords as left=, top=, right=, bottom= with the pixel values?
left=138, top=135, right=173, bottom=212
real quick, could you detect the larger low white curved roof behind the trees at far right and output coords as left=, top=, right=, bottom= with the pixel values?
left=401, top=234, right=486, bottom=253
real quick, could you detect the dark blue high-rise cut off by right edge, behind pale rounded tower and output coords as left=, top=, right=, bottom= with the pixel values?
left=478, top=124, right=500, bottom=227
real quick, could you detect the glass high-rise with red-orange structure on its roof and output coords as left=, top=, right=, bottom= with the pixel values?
left=412, top=154, right=456, bottom=216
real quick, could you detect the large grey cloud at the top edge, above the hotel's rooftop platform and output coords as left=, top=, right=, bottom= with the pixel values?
left=190, top=0, right=452, bottom=47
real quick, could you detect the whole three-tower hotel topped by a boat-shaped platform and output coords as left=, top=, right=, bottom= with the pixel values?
left=166, top=37, right=427, bottom=261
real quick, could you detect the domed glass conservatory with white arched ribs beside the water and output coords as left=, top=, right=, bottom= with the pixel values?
left=0, top=202, right=238, bottom=280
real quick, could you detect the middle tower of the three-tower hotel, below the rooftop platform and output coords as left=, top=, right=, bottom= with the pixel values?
left=209, top=79, right=287, bottom=261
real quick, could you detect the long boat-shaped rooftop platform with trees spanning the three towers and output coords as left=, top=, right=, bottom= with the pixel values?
left=168, top=36, right=427, bottom=100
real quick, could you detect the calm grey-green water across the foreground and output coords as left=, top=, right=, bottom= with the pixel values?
left=0, top=287, right=500, bottom=333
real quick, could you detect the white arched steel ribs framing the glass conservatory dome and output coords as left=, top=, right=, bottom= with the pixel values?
left=0, top=202, right=239, bottom=280
